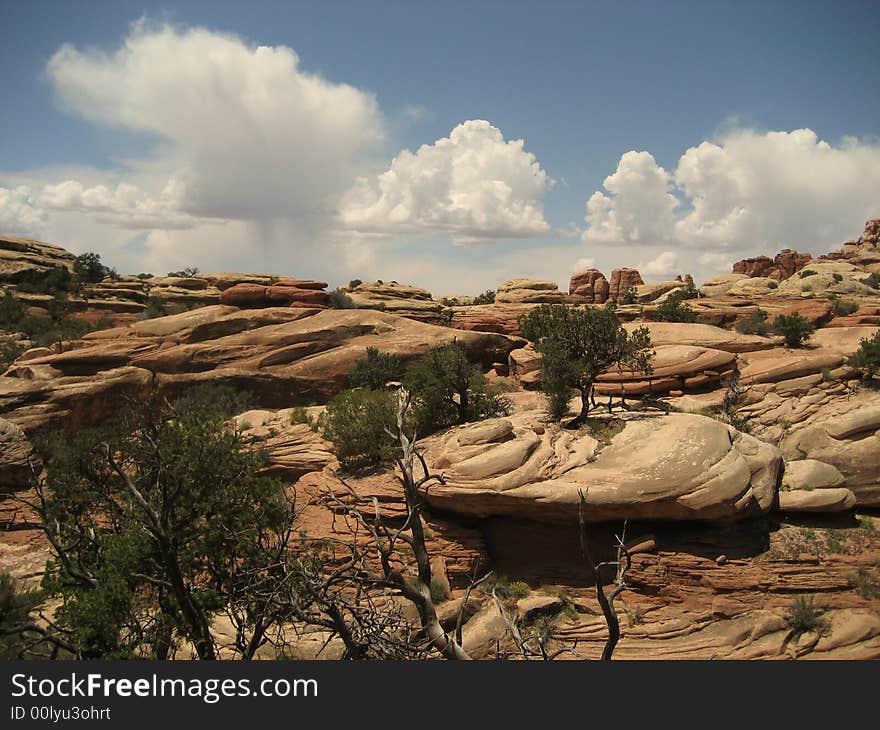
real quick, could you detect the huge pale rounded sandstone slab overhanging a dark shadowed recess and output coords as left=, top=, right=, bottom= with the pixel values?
left=425, top=411, right=782, bottom=522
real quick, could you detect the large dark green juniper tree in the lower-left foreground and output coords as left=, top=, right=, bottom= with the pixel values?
left=26, top=392, right=292, bottom=659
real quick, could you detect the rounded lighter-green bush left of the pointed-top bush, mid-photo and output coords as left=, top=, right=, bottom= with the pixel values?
left=318, top=388, right=397, bottom=471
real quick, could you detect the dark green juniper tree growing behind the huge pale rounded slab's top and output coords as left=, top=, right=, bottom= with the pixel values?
left=519, top=304, right=654, bottom=420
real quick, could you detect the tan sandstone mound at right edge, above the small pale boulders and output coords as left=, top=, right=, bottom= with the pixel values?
left=780, top=405, right=880, bottom=507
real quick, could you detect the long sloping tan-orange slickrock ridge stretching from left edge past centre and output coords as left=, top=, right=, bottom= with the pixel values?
left=0, top=306, right=525, bottom=428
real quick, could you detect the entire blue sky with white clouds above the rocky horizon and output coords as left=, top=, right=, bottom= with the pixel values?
left=0, top=1, right=880, bottom=293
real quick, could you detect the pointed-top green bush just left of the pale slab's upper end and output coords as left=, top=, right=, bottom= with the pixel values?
left=403, top=344, right=507, bottom=436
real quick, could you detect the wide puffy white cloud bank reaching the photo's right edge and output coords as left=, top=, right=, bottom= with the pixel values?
left=583, top=129, right=880, bottom=273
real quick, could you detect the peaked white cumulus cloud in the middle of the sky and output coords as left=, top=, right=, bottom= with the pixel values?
left=339, top=119, right=553, bottom=244
